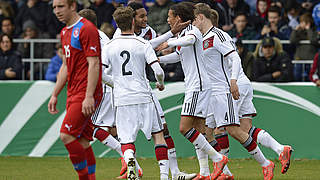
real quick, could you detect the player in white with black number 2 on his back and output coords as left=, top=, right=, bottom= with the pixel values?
left=102, top=7, right=169, bottom=180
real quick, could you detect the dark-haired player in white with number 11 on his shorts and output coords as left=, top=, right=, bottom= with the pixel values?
left=159, top=2, right=228, bottom=179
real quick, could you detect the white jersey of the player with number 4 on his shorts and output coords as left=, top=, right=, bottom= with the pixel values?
left=203, top=27, right=236, bottom=94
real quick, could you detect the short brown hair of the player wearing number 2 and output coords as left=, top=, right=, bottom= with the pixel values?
left=112, top=6, right=134, bottom=31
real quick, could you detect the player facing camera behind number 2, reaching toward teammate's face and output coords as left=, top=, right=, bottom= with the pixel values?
left=113, top=2, right=196, bottom=180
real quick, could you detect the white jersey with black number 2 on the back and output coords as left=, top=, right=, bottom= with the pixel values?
left=102, top=35, right=157, bottom=106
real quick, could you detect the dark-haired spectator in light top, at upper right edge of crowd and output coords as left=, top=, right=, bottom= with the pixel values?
left=284, top=0, right=301, bottom=29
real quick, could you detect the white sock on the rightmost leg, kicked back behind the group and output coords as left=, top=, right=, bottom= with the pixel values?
left=257, top=130, right=284, bottom=156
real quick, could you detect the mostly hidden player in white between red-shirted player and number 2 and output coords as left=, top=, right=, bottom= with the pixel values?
left=79, top=9, right=130, bottom=176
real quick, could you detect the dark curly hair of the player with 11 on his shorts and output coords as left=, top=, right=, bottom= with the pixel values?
left=170, top=2, right=195, bottom=22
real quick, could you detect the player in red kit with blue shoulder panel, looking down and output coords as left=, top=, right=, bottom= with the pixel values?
left=48, top=0, right=102, bottom=180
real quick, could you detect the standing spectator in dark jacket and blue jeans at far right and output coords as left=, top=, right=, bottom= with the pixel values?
left=290, top=13, right=319, bottom=81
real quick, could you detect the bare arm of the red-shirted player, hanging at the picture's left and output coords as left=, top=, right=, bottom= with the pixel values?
left=48, top=56, right=68, bottom=114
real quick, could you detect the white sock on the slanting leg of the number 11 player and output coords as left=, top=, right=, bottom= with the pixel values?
left=192, top=134, right=222, bottom=162
